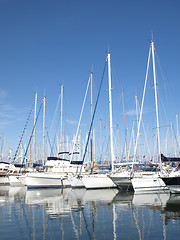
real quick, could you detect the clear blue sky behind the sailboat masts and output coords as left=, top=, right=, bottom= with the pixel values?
left=0, top=0, right=180, bottom=161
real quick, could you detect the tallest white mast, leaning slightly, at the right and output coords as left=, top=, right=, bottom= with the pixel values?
left=151, top=41, right=161, bottom=166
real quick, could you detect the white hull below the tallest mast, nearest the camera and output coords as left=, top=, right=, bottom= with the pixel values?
left=131, top=176, right=169, bottom=193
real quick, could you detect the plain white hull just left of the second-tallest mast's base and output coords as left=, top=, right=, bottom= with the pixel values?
left=82, top=174, right=116, bottom=189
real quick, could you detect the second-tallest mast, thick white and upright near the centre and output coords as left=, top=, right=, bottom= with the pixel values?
left=108, top=53, right=114, bottom=172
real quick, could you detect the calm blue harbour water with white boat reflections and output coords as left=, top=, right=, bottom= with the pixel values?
left=0, top=186, right=180, bottom=240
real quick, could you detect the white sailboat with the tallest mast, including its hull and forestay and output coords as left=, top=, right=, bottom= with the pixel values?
left=110, top=41, right=169, bottom=192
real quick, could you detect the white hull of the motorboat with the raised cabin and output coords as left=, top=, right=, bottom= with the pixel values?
left=25, top=172, right=67, bottom=188
